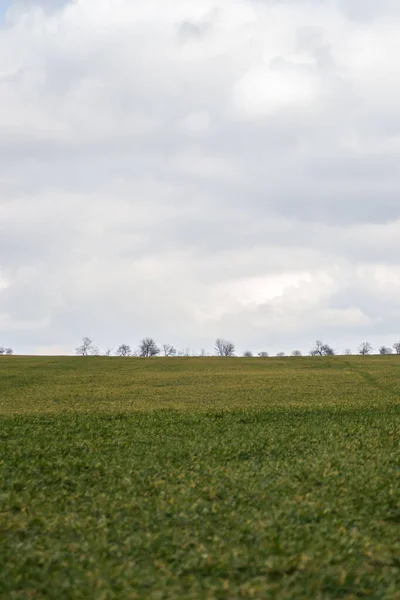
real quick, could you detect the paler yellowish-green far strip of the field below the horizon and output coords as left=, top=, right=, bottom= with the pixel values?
left=0, top=356, right=400, bottom=414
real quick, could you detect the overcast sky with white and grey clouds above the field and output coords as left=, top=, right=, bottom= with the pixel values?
left=0, top=0, right=400, bottom=354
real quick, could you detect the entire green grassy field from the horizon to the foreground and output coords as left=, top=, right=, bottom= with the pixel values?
left=0, top=356, right=400, bottom=600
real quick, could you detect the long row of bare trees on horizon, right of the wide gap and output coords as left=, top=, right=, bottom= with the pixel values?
left=76, top=337, right=400, bottom=358
